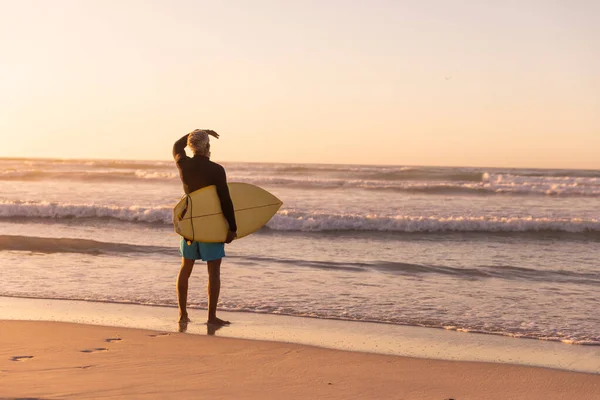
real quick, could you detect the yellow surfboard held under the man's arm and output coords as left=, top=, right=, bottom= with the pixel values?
left=173, top=182, right=283, bottom=243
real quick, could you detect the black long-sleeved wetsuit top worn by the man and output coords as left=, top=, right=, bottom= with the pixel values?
left=173, top=135, right=237, bottom=232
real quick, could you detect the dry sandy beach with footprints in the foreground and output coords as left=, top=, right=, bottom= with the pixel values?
left=0, top=320, right=600, bottom=400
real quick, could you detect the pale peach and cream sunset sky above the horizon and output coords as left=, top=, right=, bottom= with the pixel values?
left=0, top=0, right=600, bottom=169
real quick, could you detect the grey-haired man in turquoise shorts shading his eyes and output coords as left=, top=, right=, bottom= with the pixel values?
left=173, top=129, right=237, bottom=326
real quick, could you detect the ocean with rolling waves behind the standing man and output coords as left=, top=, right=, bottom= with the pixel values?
left=0, top=159, right=600, bottom=345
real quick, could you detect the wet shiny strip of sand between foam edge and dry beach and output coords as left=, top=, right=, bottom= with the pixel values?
left=0, top=297, right=600, bottom=374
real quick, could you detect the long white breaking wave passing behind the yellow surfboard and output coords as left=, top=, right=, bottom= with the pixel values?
left=0, top=201, right=600, bottom=234
